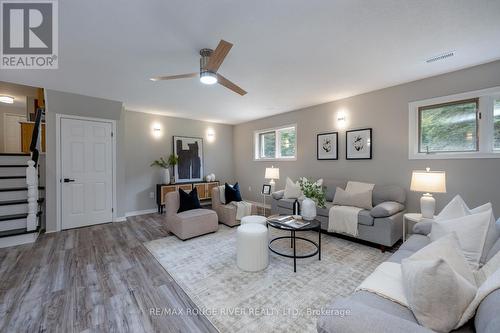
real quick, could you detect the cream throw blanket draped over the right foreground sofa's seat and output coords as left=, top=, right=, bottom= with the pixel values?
left=356, top=262, right=408, bottom=307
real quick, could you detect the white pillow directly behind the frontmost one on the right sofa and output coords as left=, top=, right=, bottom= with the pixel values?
left=407, top=232, right=476, bottom=285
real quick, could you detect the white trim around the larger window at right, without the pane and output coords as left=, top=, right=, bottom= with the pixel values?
left=408, top=86, right=500, bottom=160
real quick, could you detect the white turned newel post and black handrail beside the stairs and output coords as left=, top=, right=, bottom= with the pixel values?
left=26, top=108, right=44, bottom=231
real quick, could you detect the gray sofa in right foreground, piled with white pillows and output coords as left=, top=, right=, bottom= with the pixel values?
left=317, top=219, right=500, bottom=333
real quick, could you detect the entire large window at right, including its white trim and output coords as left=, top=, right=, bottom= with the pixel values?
left=408, top=87, right=500, bottom=159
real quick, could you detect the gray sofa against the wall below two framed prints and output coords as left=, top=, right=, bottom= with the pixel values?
left=271, top=180, right=406, bottom=249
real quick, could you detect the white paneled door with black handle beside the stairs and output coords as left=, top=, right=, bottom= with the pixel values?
left=60, top=118, right=113, bottom=229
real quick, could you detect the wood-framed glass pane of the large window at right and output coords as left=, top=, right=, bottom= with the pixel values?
left=418, top=98, right=479, bottom=153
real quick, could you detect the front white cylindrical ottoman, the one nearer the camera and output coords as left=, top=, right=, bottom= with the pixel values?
left=236, top=223, right=269, bottom=272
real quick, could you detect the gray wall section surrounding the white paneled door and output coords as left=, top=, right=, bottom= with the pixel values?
left=45, top=90, right=125, bottom=231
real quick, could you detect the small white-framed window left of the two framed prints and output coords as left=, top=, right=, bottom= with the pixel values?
left=255, top=125, right=297, bottom=160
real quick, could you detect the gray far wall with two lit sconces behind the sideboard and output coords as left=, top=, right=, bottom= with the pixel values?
left=124, top=111, right=234, bottom=212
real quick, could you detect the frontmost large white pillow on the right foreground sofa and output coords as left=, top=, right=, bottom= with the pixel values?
left=401, top=259, right=477, bottom=332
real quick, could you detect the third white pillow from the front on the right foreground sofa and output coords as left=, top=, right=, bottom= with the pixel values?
left=430, top=210, right=492, bottom=269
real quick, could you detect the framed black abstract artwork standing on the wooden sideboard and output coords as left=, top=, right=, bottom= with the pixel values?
left=174, top=136, right=203, bottom=183
